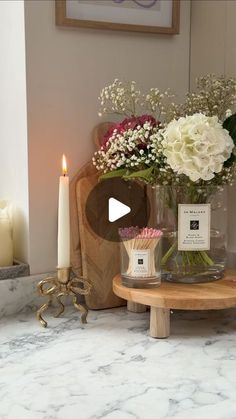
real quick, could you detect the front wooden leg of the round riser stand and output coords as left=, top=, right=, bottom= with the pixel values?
left=150, top=307, right=170, bottom=338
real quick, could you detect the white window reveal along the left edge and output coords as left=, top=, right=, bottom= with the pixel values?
left=0, top=0, right=29, bottom=262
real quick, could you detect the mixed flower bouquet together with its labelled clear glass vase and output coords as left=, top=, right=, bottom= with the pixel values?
left=93, top=75, right=236, bottom=282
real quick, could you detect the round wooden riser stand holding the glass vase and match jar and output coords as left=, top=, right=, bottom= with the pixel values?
left=113, top=270, right=236, bottom=338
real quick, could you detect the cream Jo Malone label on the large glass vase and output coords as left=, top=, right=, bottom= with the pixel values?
left=178, top=204, right=211, bottom=251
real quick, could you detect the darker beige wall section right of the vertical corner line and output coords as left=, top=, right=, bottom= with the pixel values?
left=190, top=0, right=236, bottom=256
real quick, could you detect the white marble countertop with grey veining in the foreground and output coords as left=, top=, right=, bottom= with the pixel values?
left=0, top=308, right=236, bottom=419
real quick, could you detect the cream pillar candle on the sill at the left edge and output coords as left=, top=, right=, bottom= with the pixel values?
left=0, top=201, right=13, bottom=266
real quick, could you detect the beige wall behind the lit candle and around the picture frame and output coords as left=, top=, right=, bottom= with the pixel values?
left=25, top=0, right=190, bottom=273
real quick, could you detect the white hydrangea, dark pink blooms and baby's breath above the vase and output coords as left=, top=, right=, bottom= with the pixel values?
left=93, top=74, right=236, bottom=189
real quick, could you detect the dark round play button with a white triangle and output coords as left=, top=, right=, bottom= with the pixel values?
left=85, top=178, right=150, bottom=242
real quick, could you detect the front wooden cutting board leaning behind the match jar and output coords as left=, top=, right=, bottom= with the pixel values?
left=76, top=174, right=125, bottom=309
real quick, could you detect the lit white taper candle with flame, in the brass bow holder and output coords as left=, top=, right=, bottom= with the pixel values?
left=58, top=155, right=70, bottom=268
